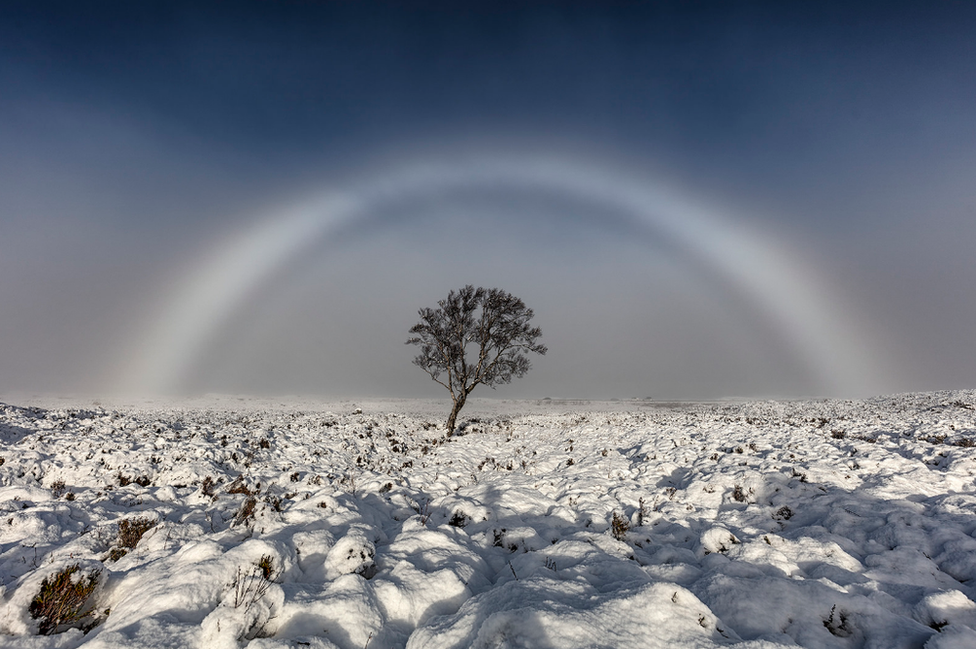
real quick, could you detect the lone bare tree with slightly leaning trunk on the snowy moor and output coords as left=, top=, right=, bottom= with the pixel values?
left=407, top=284, right=546, bottom=433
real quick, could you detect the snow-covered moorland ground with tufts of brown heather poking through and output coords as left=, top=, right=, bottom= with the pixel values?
left=0, top=392, right=976, bottom=649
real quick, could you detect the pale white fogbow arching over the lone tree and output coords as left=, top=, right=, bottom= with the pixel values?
left=122, top=156, right=877, bottom=394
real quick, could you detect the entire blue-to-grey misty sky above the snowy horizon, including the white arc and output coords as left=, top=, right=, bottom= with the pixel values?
left=0, top=1, right=976, bottom=399
